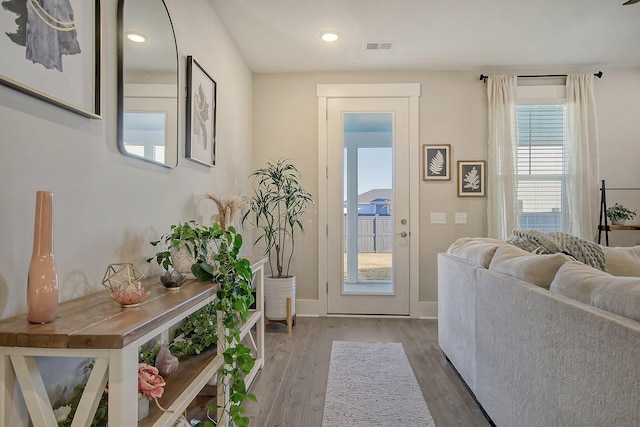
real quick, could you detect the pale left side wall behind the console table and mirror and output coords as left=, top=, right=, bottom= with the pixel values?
left=0, top=0, right=252, bottom=319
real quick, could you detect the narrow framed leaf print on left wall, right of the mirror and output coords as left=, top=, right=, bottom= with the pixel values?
left=185, top=56, right=216, bottom=166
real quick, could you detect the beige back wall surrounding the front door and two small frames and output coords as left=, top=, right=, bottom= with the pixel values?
left=253, top=68, right=640, bottom=314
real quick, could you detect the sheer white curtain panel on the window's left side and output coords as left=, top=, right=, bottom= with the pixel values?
left=486, top=75, right=518, bottom=240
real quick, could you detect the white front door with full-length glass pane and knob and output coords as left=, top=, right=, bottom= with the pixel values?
left=326, top=98, right=411, bottom=315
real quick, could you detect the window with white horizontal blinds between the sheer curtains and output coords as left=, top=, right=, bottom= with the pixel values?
left=516, top=105, right=567, bottom=232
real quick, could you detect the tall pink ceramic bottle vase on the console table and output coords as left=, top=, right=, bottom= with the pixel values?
left=27, top=191, right=58, bottom=323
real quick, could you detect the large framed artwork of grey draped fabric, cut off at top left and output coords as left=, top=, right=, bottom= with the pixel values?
left=0, top=0, right=101, bottom=119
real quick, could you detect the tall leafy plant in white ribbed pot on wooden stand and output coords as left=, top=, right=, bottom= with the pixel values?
left=242, top=159, right=313, bottom=332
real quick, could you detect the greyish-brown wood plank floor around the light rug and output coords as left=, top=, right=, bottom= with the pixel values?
left=245, top=317, right=491, bottom=427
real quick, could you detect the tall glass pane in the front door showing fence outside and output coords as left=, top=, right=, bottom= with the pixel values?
left=342, top=112, right=394, bottom=294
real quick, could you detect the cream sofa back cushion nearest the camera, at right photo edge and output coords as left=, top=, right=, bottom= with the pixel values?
left=550, top=261, right=640, bottom=321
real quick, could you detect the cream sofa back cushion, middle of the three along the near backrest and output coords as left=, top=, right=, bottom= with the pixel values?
left=489, top=245, right=573, bottom=289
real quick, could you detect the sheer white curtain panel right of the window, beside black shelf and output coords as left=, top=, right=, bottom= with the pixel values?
left=567, top=74, right=600, bottom=240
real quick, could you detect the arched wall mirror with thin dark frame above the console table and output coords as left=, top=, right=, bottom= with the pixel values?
left=118, top=0, right=178, bottom=167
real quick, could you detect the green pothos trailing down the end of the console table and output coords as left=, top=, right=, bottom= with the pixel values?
left=191, top=223, right=256, bottom=427
